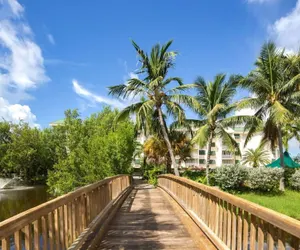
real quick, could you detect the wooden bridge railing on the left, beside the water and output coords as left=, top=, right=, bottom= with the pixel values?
left=0, top=175, right=131, bottom=250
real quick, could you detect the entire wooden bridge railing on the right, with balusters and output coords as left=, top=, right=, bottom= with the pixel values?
left=158, top=175, right=300, bottom=250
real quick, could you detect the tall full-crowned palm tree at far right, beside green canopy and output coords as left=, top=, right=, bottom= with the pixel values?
left=239, top=42, right=300, bottom=190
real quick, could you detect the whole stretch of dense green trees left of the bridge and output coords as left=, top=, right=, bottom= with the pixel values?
left=0, top=107, right=135, bottom=195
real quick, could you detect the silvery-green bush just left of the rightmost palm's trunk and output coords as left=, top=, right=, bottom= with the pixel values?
left=249, top=167, right=283, bottom=192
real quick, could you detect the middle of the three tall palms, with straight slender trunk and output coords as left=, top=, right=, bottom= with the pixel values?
left=179, top=74, right=252, bottom=184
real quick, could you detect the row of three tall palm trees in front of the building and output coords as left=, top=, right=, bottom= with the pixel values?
left=109, top=41, right=300, bottom=188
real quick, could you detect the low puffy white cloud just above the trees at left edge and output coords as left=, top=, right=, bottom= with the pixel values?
left=0, top=97, right=39, bottom=127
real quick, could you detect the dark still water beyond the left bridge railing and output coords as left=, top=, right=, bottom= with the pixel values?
left=0, top=186, right=50, bottom=222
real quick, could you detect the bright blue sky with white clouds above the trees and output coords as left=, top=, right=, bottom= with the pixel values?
left=0, top=0, right=300, bottom=152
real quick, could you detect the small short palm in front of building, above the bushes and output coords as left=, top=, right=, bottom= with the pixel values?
left=242, top=144, right=270, bottom=168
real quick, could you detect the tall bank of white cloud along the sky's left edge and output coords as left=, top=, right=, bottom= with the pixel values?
left=0, top=0, right=49, bottom=125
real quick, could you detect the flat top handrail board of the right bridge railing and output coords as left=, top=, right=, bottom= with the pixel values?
left=158, top=175, right=300, bottom=238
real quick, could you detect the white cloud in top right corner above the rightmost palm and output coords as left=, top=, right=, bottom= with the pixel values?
left=270, top=0, right=300, bottom=53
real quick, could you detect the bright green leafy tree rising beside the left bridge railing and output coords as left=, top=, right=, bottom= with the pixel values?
left=47, top=108, right=135, bottom=195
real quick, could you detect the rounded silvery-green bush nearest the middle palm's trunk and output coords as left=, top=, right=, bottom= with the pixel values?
left=214, top=165, right=248, bottom=190
